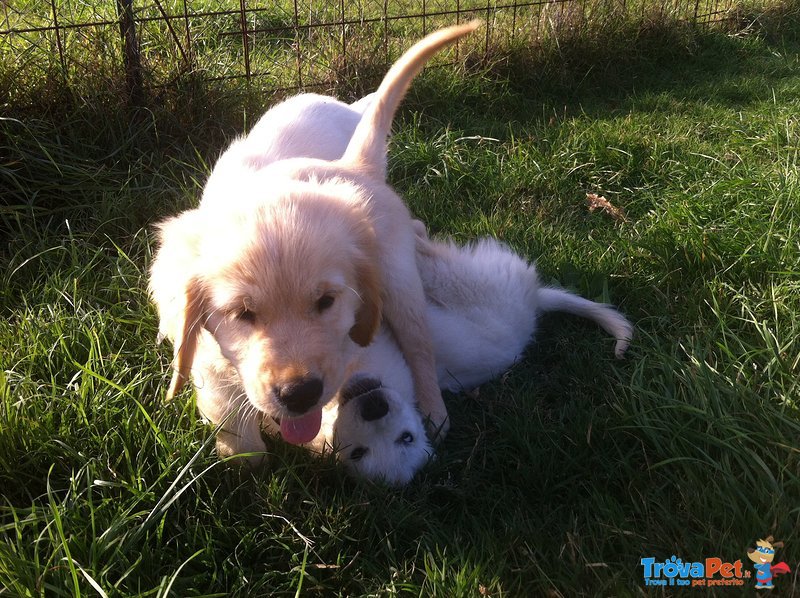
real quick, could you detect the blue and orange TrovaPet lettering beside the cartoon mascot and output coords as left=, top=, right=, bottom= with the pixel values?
left=641, top=556, right=751, bottom=587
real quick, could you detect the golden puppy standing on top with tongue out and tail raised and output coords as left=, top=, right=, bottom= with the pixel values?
left=150, top=23, right=478, bottom=462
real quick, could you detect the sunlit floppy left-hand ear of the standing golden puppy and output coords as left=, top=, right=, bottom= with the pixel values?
left=149, top=210, right=205, bottom=400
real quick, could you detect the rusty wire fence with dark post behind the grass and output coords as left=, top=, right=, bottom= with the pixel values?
left=0, top=0, right=733, bottom=101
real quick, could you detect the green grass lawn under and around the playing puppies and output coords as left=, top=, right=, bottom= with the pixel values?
left=0, top=5, right=800, bottom=597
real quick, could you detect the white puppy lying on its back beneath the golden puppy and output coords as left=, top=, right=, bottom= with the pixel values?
left=304, top=226, right=633, bottom=485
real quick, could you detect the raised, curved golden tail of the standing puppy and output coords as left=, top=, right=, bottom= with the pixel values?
left=342, top=21, right=481, bottom=178
